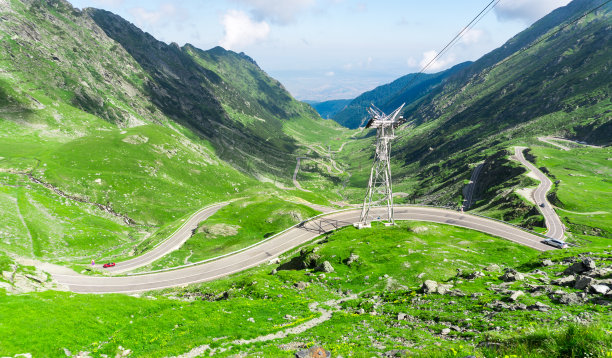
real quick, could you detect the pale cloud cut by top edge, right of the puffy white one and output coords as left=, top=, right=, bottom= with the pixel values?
left=235, top=0, right=316, bottom=25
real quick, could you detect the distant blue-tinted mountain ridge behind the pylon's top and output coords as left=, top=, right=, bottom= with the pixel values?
left=333, top=62, right=470, bottom=128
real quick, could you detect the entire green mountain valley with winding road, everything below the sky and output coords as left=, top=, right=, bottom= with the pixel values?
left=0, top=0, right=612, bottom=357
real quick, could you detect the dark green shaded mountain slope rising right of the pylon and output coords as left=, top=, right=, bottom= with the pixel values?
left=384, top=0, right=612, bottom=210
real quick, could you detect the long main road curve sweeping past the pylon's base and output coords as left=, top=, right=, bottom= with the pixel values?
left=52, top=206, right=553, bottom=293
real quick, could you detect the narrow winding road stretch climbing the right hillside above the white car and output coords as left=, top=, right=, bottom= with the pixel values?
left=514, top=147, right=565, bottom=240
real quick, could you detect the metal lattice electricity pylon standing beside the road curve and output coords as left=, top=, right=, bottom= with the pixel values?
left=355, top=104, right=404, bottom=229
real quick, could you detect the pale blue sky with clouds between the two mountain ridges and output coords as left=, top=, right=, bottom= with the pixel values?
left=69, top=0, right=570, bottom=101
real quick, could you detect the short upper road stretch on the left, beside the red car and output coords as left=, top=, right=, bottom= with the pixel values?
left=104, top=202, right=229, bottom=273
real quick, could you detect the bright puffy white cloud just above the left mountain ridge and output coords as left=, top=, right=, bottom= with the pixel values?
left=219, top=10, right=270, bottom=50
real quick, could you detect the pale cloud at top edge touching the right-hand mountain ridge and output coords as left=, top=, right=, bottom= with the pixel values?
left=495, top=0, right=571, bottom=24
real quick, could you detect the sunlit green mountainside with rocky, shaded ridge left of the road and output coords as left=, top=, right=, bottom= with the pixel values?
left=0, top=0, right=346, bottom=261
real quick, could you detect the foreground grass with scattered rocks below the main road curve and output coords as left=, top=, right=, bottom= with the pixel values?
left=0, top=222, right=612, bottom=357
